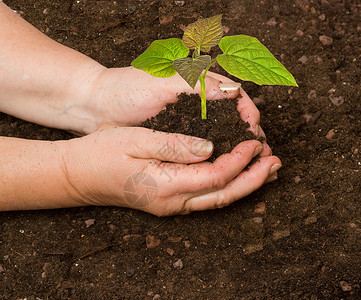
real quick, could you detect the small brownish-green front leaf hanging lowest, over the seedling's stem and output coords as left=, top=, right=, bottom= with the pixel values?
left=173, top=55, right=211, bottom=89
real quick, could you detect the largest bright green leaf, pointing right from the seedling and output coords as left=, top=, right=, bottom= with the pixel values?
left=217, top=35, right=298, bottom=86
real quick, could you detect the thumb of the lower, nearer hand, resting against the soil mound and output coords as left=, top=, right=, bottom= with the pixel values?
left=127, top=128, right=213, bottom=164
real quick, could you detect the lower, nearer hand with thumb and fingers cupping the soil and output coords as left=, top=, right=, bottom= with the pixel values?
left=60, top=126, right=281, bottom=216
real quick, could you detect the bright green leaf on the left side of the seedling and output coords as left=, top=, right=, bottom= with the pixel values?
left=132, top=38, right=189, bottom=77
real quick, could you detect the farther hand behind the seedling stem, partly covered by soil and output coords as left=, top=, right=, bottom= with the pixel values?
left=84, top=67, right=271, bottom=156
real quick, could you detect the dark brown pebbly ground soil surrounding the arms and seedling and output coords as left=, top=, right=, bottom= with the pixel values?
left=0, top=0, right=361, bottom=299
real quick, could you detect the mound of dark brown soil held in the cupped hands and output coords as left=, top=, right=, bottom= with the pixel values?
left=141, top=94, right=257, bottom=161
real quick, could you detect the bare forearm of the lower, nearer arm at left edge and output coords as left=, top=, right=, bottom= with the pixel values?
left=0, top=137, right=84, bottom=211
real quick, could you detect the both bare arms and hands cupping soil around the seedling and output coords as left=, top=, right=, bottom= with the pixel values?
left=0, top=2, right=281, bottom=216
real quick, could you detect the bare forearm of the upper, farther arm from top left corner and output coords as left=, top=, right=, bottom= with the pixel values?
left=0, top=2, right=105, bottom=132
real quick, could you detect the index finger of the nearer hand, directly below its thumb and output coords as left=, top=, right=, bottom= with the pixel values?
left=153, top=140, right=263, bottom=196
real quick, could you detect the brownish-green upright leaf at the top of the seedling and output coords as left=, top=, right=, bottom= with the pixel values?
left=183, top=15, right=223, bottom=52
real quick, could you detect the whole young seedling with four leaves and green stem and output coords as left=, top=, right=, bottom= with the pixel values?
left=132, top=15, right=298, bottom=119
